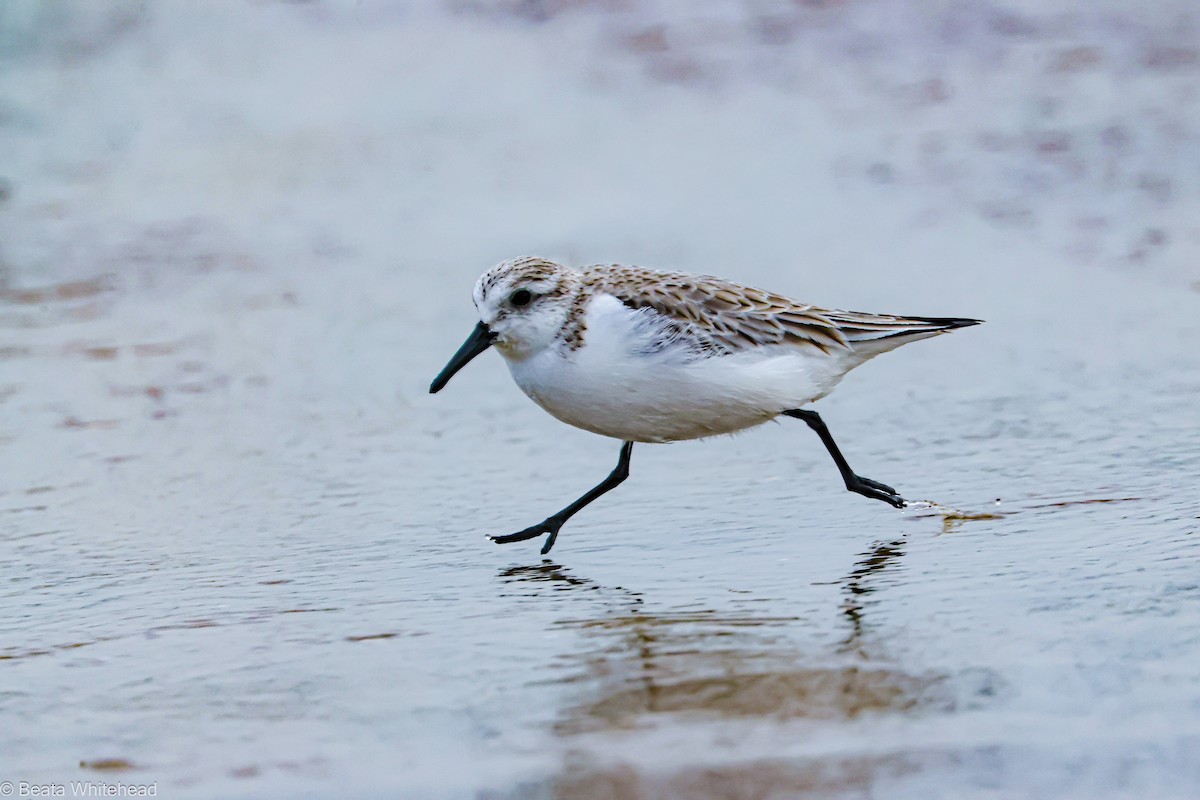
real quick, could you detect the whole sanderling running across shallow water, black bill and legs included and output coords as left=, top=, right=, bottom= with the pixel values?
left=430, top=257, right=980, bottom=554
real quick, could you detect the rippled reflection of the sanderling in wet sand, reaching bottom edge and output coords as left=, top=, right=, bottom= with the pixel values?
left=525, top=539, right=956, bottom=798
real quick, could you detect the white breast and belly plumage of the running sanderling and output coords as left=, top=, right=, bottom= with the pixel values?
left=508, top=295, right=854, bottom=441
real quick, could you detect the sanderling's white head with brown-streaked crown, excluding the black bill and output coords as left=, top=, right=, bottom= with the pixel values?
left=474, top=257, right=580, bottom=360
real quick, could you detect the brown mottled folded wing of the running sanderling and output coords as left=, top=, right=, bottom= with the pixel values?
left=584, top=265, right=848, bottom=355
